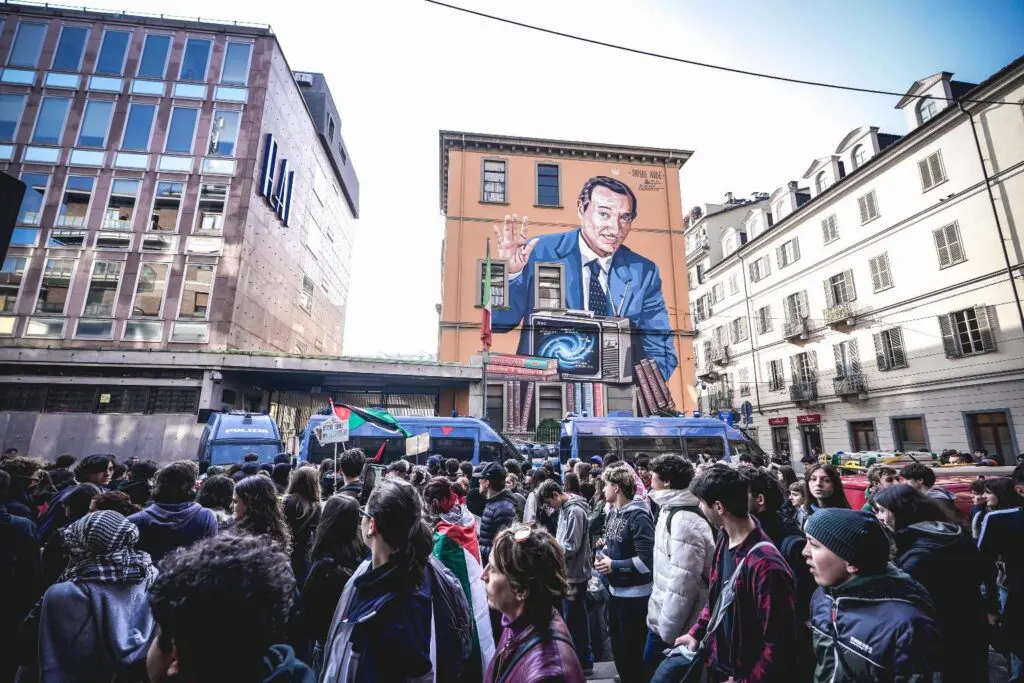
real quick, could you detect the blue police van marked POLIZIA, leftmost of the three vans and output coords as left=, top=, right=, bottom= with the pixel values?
left=197, top=411, right=285, bottom=470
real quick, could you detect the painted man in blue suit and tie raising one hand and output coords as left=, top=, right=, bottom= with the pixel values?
left=492, top=175, right=679, bottom=380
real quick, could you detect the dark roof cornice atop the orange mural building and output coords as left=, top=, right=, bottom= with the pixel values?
left=438, top=130, right=693, bottom=213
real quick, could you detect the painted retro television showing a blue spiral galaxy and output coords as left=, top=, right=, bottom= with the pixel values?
left=523, top=310, right=633, bottom=384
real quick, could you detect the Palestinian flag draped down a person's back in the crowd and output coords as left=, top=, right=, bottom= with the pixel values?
left=434, top=505, right=495, bottom=681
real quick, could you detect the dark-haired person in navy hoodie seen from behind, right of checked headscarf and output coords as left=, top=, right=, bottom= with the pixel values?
left=128, top=461, right=219, bottom=563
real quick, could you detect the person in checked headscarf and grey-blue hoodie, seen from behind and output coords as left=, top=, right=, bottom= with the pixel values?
left=38, top=510, right=157, bottom=683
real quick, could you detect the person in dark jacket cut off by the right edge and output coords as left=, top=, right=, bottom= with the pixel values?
left=978, top=465, right=1024, bottom=683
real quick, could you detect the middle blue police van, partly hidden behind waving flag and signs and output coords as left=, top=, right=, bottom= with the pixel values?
left=299, top=415, right=524, bottom=465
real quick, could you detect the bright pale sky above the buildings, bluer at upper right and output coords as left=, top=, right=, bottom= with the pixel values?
left=77, top=0, right=1024, bottom=355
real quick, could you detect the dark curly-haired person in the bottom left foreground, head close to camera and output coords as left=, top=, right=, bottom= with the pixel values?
left=146, top=532, right=315, bottom=683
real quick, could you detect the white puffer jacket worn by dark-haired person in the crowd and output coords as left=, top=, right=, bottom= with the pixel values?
left=647, top=488, right=715, bottom=645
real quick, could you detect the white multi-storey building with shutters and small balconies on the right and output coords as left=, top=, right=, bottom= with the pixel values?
left=687, top=59, right=1024, bottom=464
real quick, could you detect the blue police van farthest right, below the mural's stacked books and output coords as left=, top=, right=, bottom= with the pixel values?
left=558, top=417, right=764, bottom=463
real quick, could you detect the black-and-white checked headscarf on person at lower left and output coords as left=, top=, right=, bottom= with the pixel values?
left=60, top=510, right=157, bottom=585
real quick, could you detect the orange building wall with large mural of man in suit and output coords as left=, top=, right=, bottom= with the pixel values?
left=438, top=131, right=696, bottom=433
